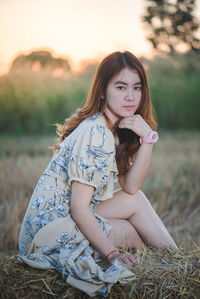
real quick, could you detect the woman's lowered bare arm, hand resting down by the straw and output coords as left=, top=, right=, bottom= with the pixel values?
left=71, top=181, right=136, bottom=266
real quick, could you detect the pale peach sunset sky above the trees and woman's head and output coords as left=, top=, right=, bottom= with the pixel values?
left=0, top=0, right=199, bottom=74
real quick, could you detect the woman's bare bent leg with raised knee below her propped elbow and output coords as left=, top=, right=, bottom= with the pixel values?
left=95, top=190, right=177, bottom=249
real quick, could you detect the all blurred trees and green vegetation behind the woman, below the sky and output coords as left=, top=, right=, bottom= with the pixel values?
left=0, top=0, right=200, bottom=135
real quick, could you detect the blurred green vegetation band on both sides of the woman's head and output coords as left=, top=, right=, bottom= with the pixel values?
left=0, top=54, right=200, bottom=136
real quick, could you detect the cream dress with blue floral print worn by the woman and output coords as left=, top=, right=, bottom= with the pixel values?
left=18, top=113, right=134, bottom=296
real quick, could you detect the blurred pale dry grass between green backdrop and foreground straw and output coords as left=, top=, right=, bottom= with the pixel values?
left=0, top=131, right=200, bottom=254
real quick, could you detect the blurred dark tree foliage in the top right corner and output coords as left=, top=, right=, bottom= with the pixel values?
left=142, top=0, right=200, bottom=54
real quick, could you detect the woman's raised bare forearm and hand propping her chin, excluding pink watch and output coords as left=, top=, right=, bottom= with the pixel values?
left=119, top=115, right=153, bottom=194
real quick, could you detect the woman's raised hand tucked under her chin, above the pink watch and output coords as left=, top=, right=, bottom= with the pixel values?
left=118, top=114, right=152, bottom=137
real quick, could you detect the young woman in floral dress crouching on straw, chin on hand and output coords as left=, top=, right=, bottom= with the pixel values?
left=19, top=51, right=177, bottom=296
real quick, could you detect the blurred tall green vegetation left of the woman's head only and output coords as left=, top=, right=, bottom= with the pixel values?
left=0, top=70, right=89, bottom=135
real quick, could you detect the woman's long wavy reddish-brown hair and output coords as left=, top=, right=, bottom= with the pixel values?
left=53, top=51, right=157, bottom=174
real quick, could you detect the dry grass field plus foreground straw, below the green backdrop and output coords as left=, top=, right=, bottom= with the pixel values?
left=0, top=132, right=200, bottom=298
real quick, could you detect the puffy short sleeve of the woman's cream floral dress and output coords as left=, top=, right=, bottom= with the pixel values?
left=60, top=124, right=118, bottom=195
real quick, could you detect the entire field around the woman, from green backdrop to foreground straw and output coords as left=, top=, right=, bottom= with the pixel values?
left=0, top=53, right=200, bottom=299
